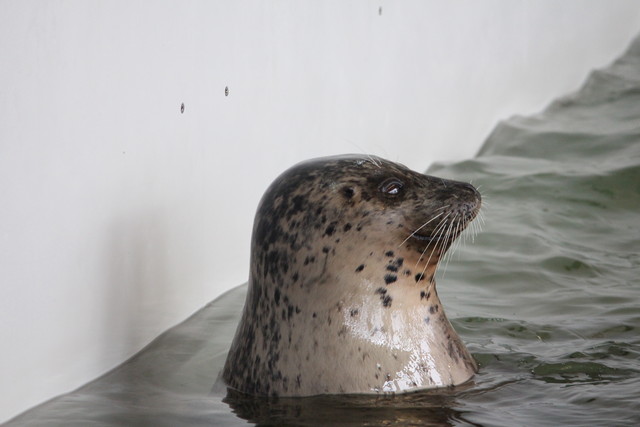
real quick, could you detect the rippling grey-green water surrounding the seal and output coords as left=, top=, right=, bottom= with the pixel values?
left=8, top=39, right=640, bottom=426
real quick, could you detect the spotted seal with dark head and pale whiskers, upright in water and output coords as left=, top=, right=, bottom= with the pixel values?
left=222, top=155, right=481, bottom=396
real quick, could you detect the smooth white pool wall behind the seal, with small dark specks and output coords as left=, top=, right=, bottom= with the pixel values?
left=0, top=0, right=640, bottom=421
